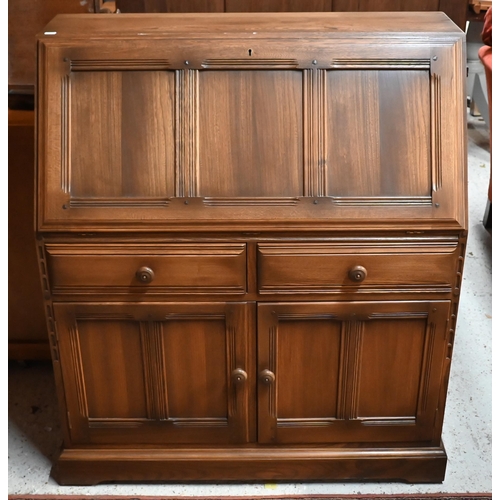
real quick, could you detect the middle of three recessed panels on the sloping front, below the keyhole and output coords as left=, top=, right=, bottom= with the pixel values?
left=199, top=70, right=303, bottom=197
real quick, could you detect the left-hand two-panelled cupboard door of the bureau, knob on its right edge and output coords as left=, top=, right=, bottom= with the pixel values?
left=54, top=303, right=255, bottom=444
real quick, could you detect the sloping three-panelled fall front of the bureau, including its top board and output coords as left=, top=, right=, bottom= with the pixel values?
left=37, top=13, right=467, bottom=231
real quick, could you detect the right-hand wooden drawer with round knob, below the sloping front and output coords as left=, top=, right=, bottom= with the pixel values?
left=257, top=239, right=462, bottom=294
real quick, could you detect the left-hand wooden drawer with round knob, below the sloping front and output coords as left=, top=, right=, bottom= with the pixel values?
left=46, top=243, right=246, bottom=294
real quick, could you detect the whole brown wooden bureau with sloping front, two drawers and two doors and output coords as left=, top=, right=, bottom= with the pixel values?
left=36, top=12, right=467, bottom=484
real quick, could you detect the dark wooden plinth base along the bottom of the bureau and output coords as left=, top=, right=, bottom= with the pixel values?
left=52, top=446, right=447, bottom=485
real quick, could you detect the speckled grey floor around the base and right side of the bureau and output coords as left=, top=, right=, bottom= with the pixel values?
left=8, top=109, right=492, bottom=496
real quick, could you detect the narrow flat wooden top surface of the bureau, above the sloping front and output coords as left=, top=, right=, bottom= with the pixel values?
left=39, top=12, right=463, bottom=38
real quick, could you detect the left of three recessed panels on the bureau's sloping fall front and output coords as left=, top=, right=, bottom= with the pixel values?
left=68, top=71, right=175, bottom=204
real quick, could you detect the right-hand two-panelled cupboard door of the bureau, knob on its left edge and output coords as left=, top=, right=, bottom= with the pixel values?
left=257, top=301, right=450, bottom=444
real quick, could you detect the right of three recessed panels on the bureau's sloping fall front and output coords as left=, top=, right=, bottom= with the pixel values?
left=326, top=68, right=432, bottom=199
